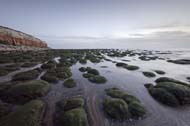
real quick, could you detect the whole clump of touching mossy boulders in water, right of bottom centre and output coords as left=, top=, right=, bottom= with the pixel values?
left=103, top=88, right=146, bottom=120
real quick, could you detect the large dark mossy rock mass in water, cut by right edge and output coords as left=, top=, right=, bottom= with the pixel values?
left=145, top=77, right=190, bottom=106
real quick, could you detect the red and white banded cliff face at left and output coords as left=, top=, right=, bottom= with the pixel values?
left=0, top=26, right=47, bottom=48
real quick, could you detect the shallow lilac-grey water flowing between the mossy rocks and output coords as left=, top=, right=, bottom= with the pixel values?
left=0, top=51, right=190, bottom=126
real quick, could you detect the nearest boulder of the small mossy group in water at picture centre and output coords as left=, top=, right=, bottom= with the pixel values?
left=88, top=75, right=107, bottom=84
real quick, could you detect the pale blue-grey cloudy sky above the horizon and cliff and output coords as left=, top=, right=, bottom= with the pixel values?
left=0, top=0, right=190, bottom=49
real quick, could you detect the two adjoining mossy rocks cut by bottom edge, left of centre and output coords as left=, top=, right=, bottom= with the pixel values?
left=56, top=97, right=88, bottom=126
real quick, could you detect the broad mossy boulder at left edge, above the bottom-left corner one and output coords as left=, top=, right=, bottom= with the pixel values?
left=0, top=80, right=49, bottom=104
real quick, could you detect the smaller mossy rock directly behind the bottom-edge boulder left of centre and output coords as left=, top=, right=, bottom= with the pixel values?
left=56, top=97, right=84, bottom=111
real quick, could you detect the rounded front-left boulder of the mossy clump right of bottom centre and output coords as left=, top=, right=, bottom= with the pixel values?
left=103, top=98, right=130, bottom=120
